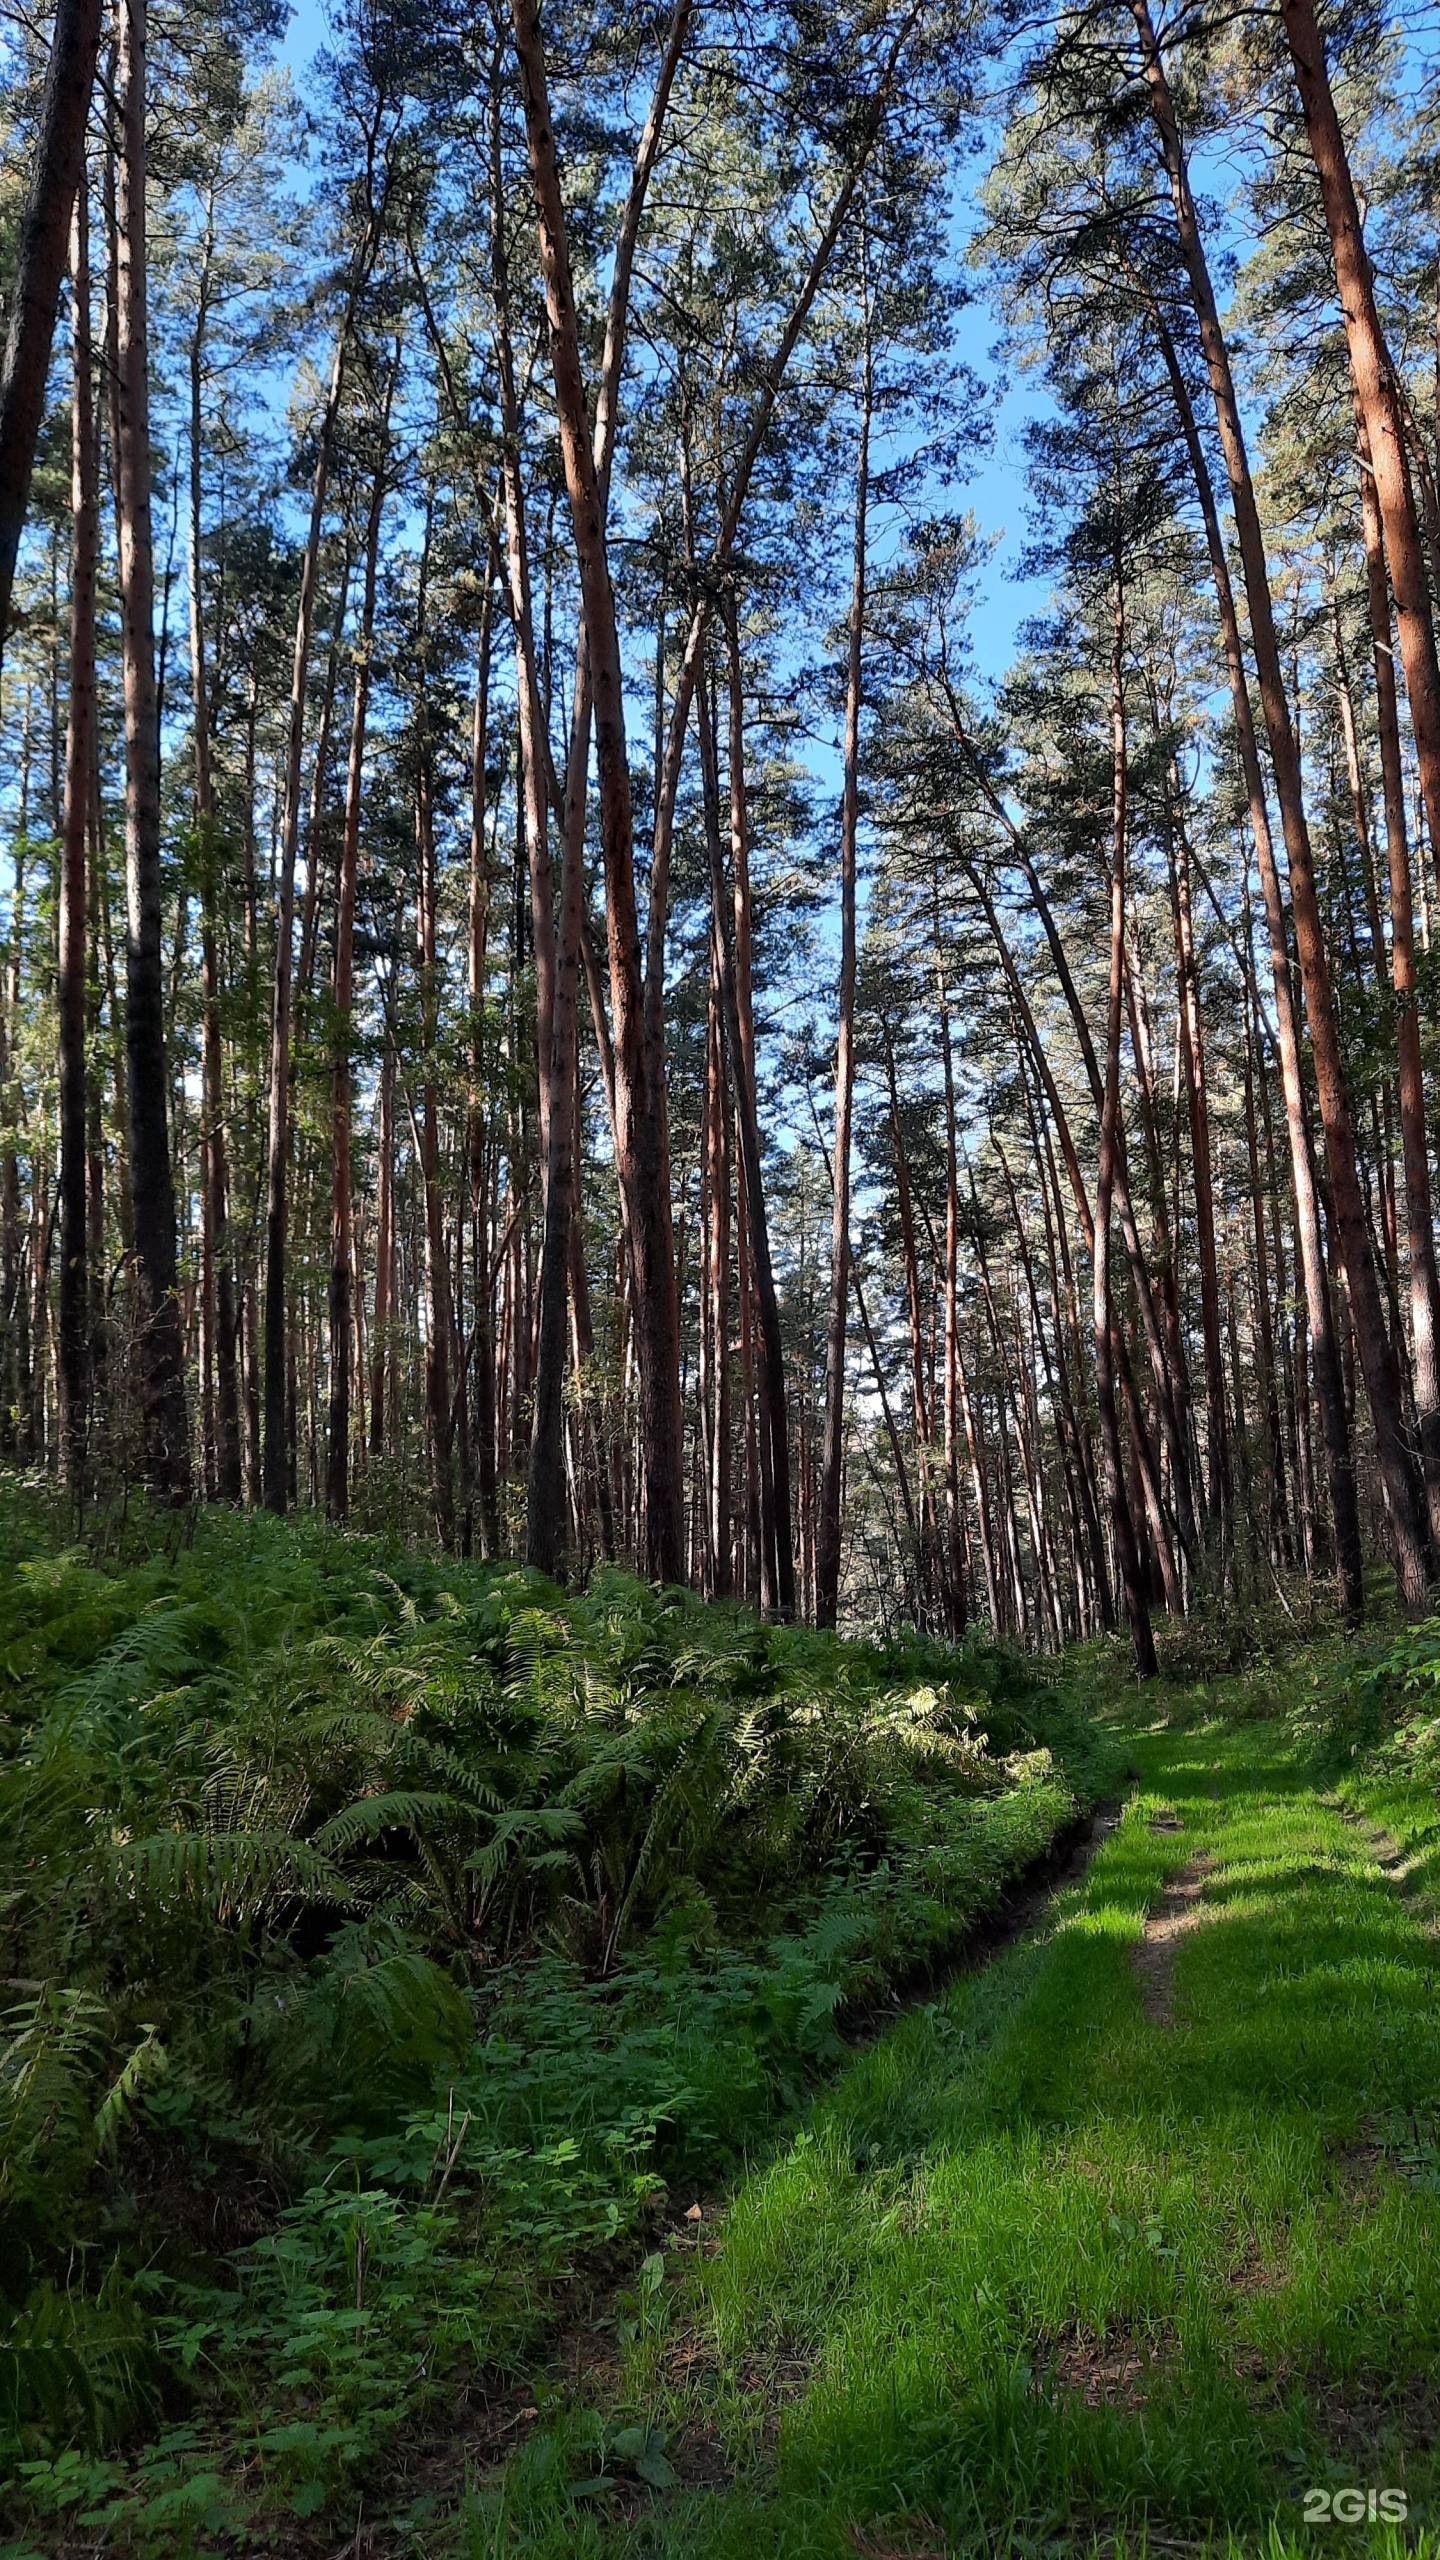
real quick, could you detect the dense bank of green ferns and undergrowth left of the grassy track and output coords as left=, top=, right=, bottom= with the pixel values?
left=0, top=1487, right=1104, bottom=2547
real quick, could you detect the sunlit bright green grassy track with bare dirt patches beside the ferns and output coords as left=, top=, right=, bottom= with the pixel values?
left=471, top=1725, right=1440, bottom=2560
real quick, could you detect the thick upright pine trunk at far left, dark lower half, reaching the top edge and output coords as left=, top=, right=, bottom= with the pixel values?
left=115, top=0, right=190, bottom=1503
